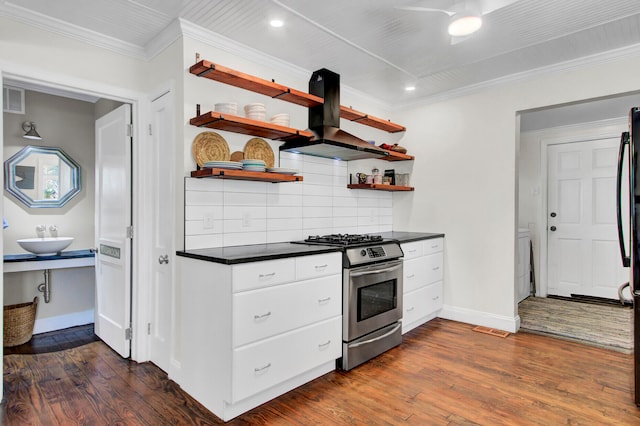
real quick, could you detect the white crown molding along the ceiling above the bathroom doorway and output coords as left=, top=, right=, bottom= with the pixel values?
left=0, top=2, right=146, bottom=58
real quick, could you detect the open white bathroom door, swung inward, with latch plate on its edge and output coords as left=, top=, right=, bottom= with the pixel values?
left=95, top=105, right=131, bottom=358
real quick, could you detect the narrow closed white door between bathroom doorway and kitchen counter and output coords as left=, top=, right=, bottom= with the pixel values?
left=148, top=92, right=175, bottom=372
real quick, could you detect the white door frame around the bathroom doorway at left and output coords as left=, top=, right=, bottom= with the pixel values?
left=0, top=64, right=153, bottom=362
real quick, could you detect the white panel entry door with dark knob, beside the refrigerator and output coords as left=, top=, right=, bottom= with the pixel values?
left=547, top=138, right=628, bottom=299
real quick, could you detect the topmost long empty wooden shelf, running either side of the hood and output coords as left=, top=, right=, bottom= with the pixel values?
left=189, top=60, right=407, bottom=133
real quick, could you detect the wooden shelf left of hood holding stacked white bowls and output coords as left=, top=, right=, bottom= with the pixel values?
left=189, top=111, right=313, bottom=141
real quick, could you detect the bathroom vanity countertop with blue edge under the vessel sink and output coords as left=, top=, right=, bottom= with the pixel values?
left=4, top=249, right=96, bottom=272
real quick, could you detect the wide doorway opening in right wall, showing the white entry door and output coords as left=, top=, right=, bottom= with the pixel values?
left=517, top=93, right=638, bottom=348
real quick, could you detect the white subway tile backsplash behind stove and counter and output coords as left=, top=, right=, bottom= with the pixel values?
left=185, top=152, right=393, bottom=249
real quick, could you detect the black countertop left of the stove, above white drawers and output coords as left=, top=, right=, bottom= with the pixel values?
left=176, top=243, right=340, bottom=265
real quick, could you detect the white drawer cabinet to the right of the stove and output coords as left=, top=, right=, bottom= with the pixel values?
left=401, top=238, right=444, bottom=333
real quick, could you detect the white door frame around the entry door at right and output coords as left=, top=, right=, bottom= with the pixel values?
left=534, top=117, right=628, bottom=297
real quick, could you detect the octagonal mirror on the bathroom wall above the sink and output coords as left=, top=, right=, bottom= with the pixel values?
left=4, top=145, right=80, bottom=208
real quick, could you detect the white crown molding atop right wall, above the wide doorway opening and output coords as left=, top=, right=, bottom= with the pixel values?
left=399, top=43, right=640, bottom=109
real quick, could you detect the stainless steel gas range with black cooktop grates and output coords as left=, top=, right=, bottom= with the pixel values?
left=295, top=234, right=403, bottom=370
